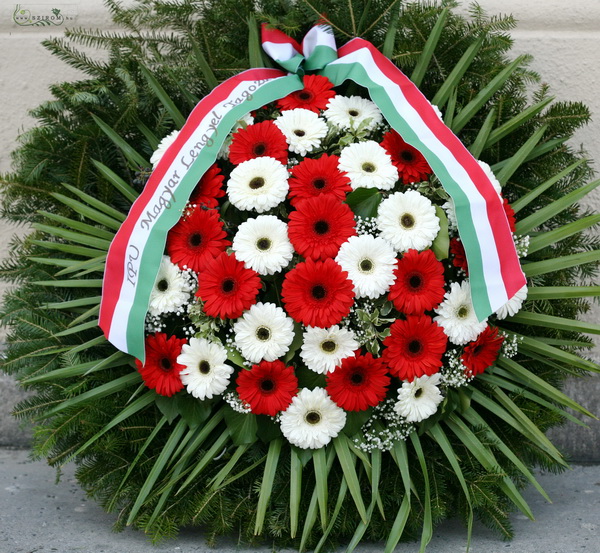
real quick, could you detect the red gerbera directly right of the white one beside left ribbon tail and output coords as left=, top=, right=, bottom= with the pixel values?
left=196, top=252, right=262, bottom=319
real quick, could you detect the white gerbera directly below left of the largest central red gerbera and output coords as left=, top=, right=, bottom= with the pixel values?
left=233, top=302, right=294, bottom=363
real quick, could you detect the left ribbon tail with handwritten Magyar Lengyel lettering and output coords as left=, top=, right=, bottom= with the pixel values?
left=99, top=69, right=303, bottom=360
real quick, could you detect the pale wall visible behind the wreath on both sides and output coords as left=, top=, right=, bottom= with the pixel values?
left=0, top=0, right=600, bottom=461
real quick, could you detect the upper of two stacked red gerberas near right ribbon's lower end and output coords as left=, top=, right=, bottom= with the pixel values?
left=388, top=250, right=444, bottom=315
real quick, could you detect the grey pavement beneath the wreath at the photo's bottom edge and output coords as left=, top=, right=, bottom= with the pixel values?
left=0, top=449, right=600, bottom=553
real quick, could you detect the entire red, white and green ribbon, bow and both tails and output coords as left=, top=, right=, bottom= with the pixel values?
left=100, top=25, right=526, bottom=359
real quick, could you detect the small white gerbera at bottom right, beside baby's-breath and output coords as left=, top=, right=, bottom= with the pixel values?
left=394, top=373, right=444, bottom=422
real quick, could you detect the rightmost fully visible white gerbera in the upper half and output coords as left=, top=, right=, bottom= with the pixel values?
left=377, top=190, right=440, bottom=252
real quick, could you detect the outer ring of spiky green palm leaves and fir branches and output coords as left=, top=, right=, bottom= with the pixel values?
left=1, top=0, right=600, bottom=552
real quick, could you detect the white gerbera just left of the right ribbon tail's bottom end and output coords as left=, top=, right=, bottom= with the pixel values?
left=433, top=280, right=487, bottom=346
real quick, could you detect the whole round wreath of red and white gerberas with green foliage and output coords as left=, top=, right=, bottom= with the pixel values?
left=1, top=0, right=600, bottom=552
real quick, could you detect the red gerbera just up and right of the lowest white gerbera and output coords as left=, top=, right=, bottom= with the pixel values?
left=327, top=353, right=390, bottom=411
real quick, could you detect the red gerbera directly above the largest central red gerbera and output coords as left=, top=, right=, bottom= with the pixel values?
left=288, top=194, right=356, bottom=260
